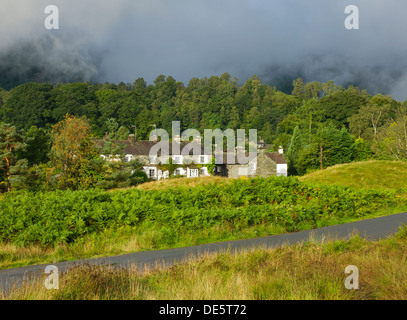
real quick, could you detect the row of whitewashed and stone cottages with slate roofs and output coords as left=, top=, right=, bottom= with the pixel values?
left=98, top=135, right=287, bottom=180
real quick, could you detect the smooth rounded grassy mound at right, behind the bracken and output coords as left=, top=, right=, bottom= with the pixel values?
left=299, top=160, right=407, bottom=190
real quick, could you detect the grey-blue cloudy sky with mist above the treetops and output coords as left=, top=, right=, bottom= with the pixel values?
left=0, top=0, right=407, bottom=100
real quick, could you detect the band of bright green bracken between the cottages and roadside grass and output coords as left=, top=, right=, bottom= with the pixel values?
left=0, top=177, right=402, bottom=245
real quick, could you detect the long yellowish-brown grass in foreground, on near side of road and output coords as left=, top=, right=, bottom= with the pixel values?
left=0, top=227, right=407, bottom=300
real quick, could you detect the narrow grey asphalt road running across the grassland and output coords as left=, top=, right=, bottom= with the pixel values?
left=0, top=212, right=407, bottom=291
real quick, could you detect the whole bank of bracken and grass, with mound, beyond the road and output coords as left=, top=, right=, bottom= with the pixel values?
left=0, top=161, right=407, bottom=269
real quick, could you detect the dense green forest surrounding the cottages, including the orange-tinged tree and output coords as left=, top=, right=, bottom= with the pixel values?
left=0, top=73, right=407, bottom=192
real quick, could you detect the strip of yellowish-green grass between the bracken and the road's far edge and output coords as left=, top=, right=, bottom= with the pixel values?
left=0, top=221, right=284, bottom=269
